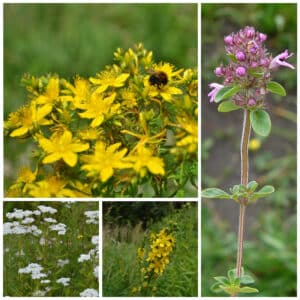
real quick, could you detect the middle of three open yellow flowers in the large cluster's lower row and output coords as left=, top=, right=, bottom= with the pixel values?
left=81, top=141, right=130, bottom=182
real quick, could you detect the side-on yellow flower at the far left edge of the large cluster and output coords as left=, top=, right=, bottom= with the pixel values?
left=5, top=102, right=52, bottom=137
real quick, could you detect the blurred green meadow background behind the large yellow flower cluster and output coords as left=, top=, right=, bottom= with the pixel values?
left=4, top=3, right=197, bottom=188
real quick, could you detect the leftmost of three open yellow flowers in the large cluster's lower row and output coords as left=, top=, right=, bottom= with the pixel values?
left=37, top=130, right=89, bottom=167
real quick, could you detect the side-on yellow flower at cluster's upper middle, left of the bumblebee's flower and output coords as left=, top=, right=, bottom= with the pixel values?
left=90, top=70, right=129, bottom=93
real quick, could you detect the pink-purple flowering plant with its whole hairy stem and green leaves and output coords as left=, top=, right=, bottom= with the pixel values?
left=202, top=26, right=294, bottom=296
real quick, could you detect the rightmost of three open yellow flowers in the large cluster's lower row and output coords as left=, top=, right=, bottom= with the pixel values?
left=124, top=144, right=165, bottom=177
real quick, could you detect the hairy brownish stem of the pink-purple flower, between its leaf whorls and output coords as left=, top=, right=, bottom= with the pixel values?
left=236, top=109, right=251, bottom=277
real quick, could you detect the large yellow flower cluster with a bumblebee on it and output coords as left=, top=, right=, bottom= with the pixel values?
left=5, top=44, right=198, bottom=197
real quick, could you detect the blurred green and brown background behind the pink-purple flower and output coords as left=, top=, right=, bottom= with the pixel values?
left=201, top=4, right=297, bottom=297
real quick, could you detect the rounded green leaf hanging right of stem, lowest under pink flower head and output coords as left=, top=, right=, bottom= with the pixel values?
left=250, top=109, right=272, bottom=136
